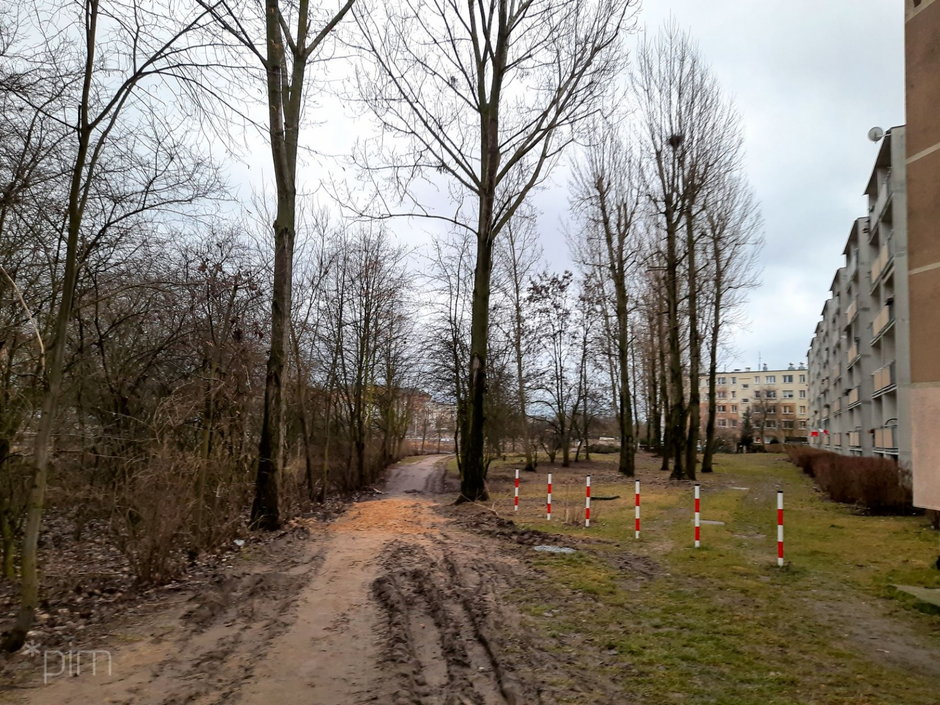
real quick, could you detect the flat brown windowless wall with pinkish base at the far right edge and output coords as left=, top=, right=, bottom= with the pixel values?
left=904, top=0, right=940, bottom=510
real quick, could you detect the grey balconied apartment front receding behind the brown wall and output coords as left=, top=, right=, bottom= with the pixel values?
left=808, top=127, right=911, bottom=478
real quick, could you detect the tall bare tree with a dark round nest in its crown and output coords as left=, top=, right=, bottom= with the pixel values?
left=634, top=25, right=741, bottom=479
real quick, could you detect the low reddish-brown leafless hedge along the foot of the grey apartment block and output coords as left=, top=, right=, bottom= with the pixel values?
left=786, top=445, right=913, bottom=514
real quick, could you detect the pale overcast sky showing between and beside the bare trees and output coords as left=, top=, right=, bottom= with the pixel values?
left=233, top=0, right=904, bottom=368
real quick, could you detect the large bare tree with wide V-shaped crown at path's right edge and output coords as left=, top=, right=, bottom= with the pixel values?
left=355, top=0, right=634, bottom=501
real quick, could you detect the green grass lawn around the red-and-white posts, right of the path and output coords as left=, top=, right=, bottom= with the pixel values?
left=489, top=454, right=940, bottom=705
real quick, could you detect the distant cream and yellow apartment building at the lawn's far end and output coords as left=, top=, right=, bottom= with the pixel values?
left=702, top=363, right=809, bottom=443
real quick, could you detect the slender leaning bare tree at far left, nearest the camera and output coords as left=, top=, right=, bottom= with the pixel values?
left=4, top=0, right=220, bottom=650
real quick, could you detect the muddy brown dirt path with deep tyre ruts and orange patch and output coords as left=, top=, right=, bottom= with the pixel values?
left=7, top=456, right=541, bottom=705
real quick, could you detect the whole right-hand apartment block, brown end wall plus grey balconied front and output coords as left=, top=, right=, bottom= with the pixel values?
left=809, top=0, right=940, bottom=510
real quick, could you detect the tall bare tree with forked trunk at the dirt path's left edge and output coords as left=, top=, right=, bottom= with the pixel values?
left=198, top=0, right=354, bottom=529
